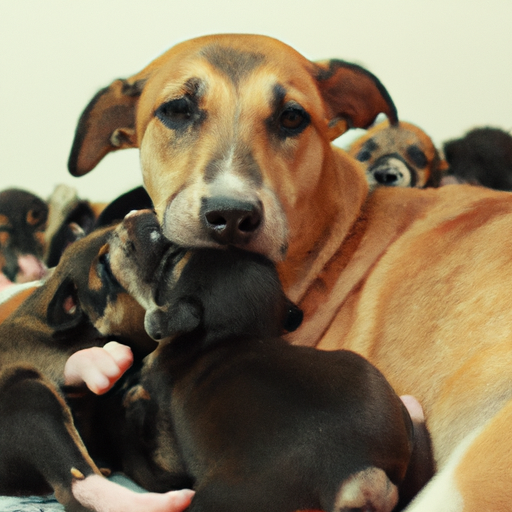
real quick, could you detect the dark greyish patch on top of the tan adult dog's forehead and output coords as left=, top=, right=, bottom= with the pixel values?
left=201, top=44, right=265, bottom=85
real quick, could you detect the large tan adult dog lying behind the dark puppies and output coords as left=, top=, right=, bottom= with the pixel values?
left=70, top=35, right=512, bottom=511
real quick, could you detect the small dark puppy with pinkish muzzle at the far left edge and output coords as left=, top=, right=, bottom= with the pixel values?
left=0, top=188, right=48, bottom=286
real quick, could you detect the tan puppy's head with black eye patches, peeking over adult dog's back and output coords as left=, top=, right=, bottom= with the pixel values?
left=349, top=121, right=447, bottom=190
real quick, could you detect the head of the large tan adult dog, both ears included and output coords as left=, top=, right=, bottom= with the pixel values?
left=69, top=34, right=397, bottom=261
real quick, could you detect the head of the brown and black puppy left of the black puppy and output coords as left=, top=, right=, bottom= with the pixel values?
left=37, top=227, right=156, bottom=353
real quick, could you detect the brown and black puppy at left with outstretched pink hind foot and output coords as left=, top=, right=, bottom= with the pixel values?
left=0, top=228, right=194, bottom=512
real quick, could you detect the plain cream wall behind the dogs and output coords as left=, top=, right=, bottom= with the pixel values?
left=0, top=0, right=512, bottom=201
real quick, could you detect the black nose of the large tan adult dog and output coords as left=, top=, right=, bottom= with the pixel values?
left=201, top=197, right=263, bottom=245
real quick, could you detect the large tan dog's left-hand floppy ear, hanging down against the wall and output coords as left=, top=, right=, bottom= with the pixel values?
left=68, top=79, right=145, bottom=176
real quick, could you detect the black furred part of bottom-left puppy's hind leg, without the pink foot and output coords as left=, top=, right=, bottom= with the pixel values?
left=0, top=367, right=99, bottom=511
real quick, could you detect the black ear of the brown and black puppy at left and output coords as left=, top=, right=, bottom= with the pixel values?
left=46, top=279, right=84, bottom=331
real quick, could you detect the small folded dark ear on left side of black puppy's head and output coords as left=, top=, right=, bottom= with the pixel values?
left=144, top=299, right=203, bottom=341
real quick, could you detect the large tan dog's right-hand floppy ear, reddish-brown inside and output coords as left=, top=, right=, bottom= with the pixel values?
left=316, top=60, right=398, bottom=140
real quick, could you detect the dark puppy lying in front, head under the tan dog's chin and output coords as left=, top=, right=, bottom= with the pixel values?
left=107, top=211, right=433, bottom=512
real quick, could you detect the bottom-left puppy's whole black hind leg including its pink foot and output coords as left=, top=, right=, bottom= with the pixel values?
left=0, top=367, right=193, bottom=512
